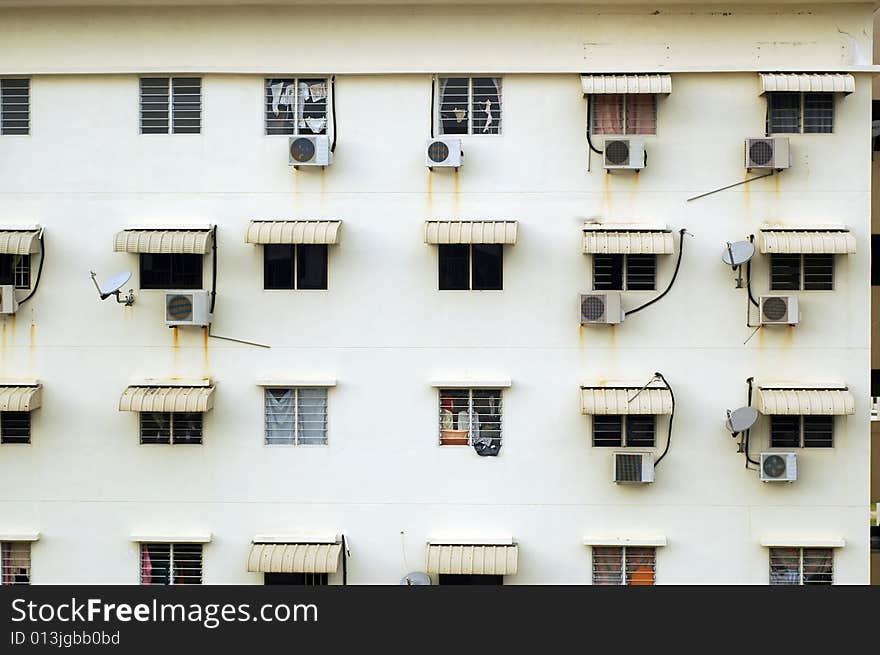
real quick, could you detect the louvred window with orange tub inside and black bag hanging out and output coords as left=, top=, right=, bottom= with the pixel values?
left=440, top=389, right=501, bottom=448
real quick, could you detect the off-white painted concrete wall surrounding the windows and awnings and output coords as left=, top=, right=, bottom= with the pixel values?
left=0, top=5, right=871, bottom=584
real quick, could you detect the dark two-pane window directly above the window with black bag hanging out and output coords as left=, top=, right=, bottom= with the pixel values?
left=437, top=243, right=504, bottom=291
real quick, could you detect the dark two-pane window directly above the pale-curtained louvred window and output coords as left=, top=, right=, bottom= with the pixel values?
left=263, top=243, right=328, bottom=289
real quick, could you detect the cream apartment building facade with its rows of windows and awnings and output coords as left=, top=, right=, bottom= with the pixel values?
left=0, top=0, right=873, bottom=584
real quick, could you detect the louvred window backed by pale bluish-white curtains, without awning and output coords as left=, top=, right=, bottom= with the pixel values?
left=265, top=388, right=327, bottom=446
